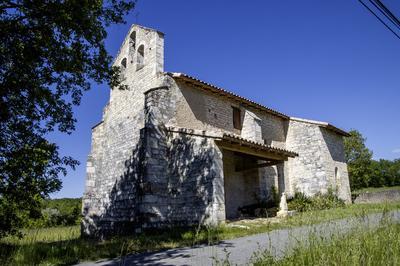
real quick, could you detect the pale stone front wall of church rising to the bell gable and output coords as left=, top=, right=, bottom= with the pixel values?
left=82, top=26, right=168, bottom=237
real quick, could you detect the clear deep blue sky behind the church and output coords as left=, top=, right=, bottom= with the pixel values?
left=51, top=0, right=400, bottom=198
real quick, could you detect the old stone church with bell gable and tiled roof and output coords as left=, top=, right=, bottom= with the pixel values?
left=82, top=25, right=350, bottom=236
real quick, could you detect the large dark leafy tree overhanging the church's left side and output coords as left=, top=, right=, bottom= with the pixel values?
left=0, top=0, right=135, bottom=237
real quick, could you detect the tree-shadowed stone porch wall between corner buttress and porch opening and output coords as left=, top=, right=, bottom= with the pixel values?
left=167, top=133, right=225, bottom=225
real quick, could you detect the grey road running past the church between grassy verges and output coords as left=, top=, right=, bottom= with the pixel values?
left=79, top=211, right=400, bottom=266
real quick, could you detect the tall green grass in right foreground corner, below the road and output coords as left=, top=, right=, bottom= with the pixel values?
left=254, top=219, right=400, bottom=266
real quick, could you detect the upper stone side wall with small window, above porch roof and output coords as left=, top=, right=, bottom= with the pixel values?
left=176, top=82, right=286, bottom=148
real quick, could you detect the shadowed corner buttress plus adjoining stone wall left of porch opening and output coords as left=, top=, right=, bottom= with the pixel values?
left=140, top=87, right=225, bottom=227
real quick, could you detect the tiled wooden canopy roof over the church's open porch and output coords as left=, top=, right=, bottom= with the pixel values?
left=215, top=133, right=298, bottom=161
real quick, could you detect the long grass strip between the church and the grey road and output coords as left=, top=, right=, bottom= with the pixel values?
left=0, top=202, right=400, bottom=265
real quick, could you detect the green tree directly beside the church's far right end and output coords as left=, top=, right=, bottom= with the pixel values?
left=344, top=130, right=372, bottom=190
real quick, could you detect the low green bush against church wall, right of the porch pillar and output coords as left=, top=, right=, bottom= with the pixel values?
left=288, top=190, right=344, bottom=212
